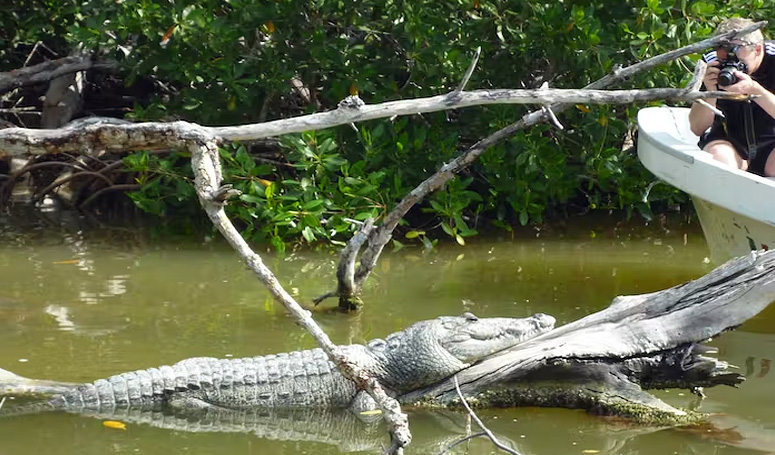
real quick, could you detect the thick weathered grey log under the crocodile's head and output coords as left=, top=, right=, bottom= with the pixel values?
left=399, top=251, right=775, bottom=425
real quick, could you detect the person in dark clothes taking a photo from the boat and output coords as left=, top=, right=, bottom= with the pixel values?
left=689, top=18, right=775, bottom=177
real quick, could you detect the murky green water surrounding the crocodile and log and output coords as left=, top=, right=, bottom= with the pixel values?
left=0, top=214, right=775, bottom=455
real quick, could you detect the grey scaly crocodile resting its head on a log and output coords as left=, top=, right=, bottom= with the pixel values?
left=0, top=313, right=555, bottom=412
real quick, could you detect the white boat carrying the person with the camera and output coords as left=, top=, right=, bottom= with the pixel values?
left=638, top=106, right=775, bottom=263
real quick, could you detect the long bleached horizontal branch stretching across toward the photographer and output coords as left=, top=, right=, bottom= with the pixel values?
left=0, top=88, right=750, bottom=156
